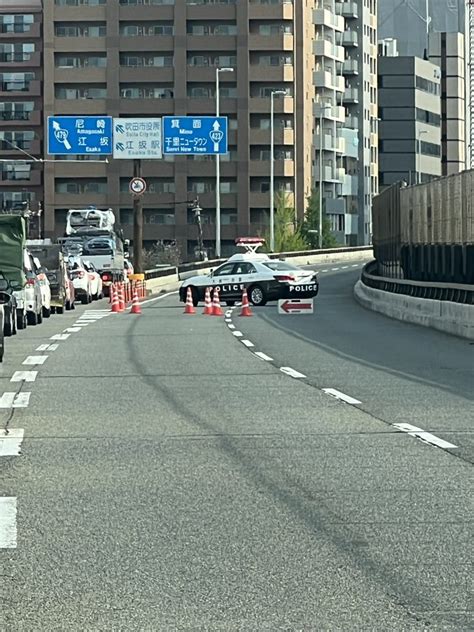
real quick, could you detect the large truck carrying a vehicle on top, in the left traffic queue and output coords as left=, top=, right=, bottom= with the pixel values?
left=58, top=207, right=128, bottom=290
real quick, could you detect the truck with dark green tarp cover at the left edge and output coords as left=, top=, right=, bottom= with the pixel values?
left=0, top=214, right=27, bottom=329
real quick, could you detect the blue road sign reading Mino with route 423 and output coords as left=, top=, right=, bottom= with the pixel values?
left=163, top=116, right=228, bottom=155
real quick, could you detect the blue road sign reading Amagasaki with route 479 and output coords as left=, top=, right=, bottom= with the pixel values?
left=48, top=116, right=113, bottom=156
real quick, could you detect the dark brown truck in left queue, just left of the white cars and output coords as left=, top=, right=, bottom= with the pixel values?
left=26, top=239, right=74, bottom=314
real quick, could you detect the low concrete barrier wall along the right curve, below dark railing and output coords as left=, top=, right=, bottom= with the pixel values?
left=354, top=281, right=474, bottom=340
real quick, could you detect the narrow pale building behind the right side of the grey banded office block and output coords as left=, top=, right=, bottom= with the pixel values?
left=428, top=33, right=467, bottom=176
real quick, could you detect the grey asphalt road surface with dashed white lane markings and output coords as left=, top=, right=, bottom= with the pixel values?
left=0, top=264, right=474, bottom=632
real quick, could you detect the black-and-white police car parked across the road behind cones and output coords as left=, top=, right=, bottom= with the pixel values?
left=179, top=239, right=319, bottom=305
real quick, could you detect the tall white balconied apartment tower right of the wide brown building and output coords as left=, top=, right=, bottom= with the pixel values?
left=314, top=0, right=378, bottom=246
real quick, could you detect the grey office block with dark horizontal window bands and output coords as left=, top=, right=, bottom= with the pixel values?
left=379, top=57, right=441, bottom=188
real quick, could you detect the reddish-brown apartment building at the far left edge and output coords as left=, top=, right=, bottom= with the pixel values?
left=0, top=0, right=43, bottom=212
